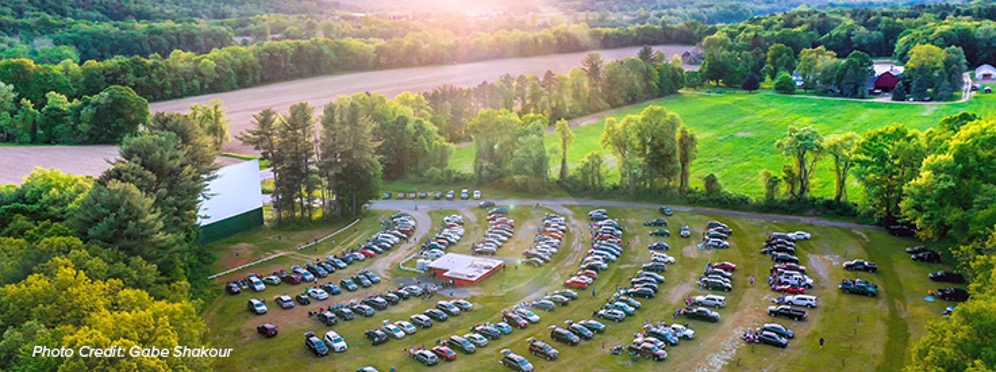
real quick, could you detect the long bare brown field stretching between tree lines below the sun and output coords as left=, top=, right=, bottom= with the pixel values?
left=149, top=45, right=689, bottom=154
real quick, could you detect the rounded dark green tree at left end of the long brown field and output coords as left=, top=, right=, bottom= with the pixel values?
left=80, top=85, right=149, bottom=144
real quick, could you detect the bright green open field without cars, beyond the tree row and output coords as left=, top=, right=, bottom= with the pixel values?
left=450, top=91, right=996, bottom=200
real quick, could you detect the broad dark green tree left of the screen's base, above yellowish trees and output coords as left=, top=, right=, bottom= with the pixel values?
left=68, top=180, right=173, bottom=268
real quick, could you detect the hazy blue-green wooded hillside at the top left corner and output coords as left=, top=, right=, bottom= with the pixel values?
left=0, top=0, right=338, bottom=21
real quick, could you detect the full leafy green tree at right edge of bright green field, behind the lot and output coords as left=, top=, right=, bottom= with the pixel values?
left=852, top=124, right=926, bottom=223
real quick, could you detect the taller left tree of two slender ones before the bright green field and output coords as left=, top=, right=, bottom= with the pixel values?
left=775, top=126, right=825, bottom=200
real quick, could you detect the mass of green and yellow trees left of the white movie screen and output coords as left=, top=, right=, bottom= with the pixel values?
left=0, top=110, right=217, bottom=370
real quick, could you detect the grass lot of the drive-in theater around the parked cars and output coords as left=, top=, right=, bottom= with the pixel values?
left=196, top=206, right=948, bottom=371
